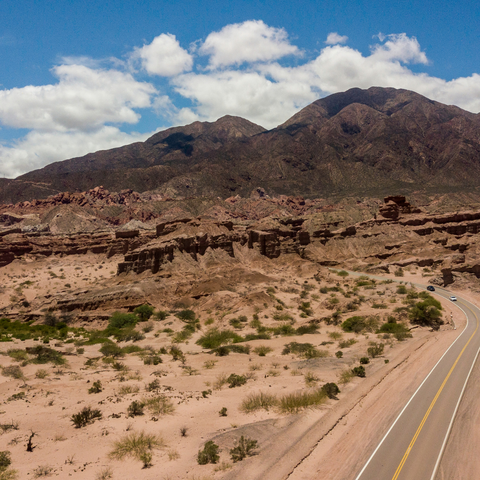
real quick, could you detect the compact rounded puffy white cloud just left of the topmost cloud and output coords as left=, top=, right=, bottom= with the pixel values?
left=132, top=33, right=193, bottom=77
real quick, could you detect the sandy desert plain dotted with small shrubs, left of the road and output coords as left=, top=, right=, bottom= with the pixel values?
left=0, top=249, right=463, bottom=480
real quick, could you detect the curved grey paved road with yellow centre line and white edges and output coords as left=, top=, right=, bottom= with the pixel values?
left=355, top=285, right=480, bottom=480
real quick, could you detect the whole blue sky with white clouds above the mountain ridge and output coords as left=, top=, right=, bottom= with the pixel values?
left=0, top=0, right=480, bottom=178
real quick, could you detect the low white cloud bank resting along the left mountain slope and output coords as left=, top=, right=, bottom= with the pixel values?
left=0, top=126, right=155, bottom=177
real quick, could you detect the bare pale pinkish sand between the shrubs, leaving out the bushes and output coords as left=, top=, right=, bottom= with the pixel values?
left=0, top=257, right=462, bottom=480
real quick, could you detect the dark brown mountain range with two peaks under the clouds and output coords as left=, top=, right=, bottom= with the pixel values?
left=0, top=87, right=480, bottom=202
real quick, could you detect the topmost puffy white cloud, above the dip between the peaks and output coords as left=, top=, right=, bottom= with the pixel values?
left=199, top=20, right=300, bottom=68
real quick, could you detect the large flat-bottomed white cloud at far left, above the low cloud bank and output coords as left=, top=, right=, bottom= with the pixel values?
left=0, top=65, right=156, bottom=131
